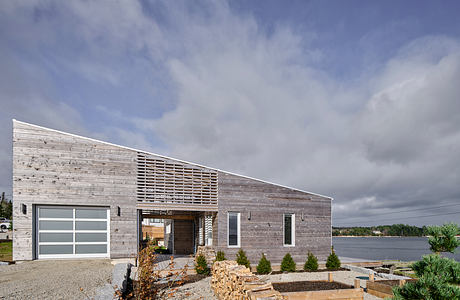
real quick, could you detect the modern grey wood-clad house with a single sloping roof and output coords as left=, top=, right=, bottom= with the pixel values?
left=13, top=120, right=332, bottom=263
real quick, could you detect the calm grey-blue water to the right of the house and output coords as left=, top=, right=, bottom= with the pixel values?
left=332, top=237, right=460, bottom=261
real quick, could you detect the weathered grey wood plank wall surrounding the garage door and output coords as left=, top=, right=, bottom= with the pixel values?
left=13, top=121, right=137, bottom=260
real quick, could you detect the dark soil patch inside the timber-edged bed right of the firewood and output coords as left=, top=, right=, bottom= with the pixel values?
left=272, top=281, right=353, bottom=293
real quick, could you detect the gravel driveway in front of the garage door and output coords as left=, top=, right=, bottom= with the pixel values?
left=0, top=259, right=113, bottom=299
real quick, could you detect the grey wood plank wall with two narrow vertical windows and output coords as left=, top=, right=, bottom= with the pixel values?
left=215, top=172, right=331, bottom=267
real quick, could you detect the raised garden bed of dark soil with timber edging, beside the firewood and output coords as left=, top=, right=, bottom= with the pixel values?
left=272, top=281, right=364, bottom=300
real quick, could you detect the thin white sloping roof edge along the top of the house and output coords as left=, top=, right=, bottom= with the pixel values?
left=12, top=119, right=334, bottom=200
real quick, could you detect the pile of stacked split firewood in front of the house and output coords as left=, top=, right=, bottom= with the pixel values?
left=211, top=260, right=283, bottom=300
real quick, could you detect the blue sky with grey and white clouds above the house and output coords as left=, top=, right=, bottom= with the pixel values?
left=0, top=0, right=460, bottom=225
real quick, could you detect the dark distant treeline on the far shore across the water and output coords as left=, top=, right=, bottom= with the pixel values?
left=332, top=224, right=426, bottom=236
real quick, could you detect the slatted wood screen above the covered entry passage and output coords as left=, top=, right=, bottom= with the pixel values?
left=137, top=152, right=218, bottom=207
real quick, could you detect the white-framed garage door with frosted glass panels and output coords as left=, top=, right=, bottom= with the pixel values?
left=36, top=206, right=110, bottom=259
